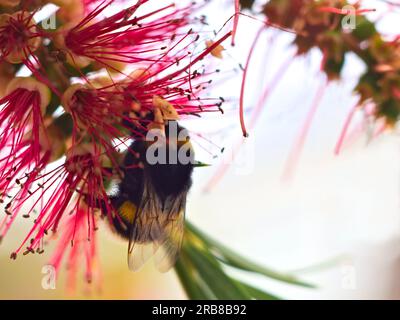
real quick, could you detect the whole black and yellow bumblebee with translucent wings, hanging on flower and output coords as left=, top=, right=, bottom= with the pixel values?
left=105, top=111, right=195, bottom=272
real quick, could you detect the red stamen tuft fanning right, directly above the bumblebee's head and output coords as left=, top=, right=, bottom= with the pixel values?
left=62, top=34, right=230, bottom=162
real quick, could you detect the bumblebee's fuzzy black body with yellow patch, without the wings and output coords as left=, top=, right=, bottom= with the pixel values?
left=106, top=122, right=194, bottom=242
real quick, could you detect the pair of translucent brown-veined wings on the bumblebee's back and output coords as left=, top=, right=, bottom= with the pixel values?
left=128, top=178, right=186, bottom=272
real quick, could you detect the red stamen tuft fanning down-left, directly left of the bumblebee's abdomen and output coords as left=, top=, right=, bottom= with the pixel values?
left=10, top=144, right=113, bottom=258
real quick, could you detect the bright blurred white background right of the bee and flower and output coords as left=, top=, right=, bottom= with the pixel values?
left=188, top=1, right=400, bottom=299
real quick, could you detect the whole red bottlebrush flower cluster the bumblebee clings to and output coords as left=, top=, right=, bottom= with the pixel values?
left=0, top=0, right=231, bottom=290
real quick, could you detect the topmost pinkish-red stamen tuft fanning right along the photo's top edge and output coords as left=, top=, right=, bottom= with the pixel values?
left=56, top=0, right=194, bottom=71
